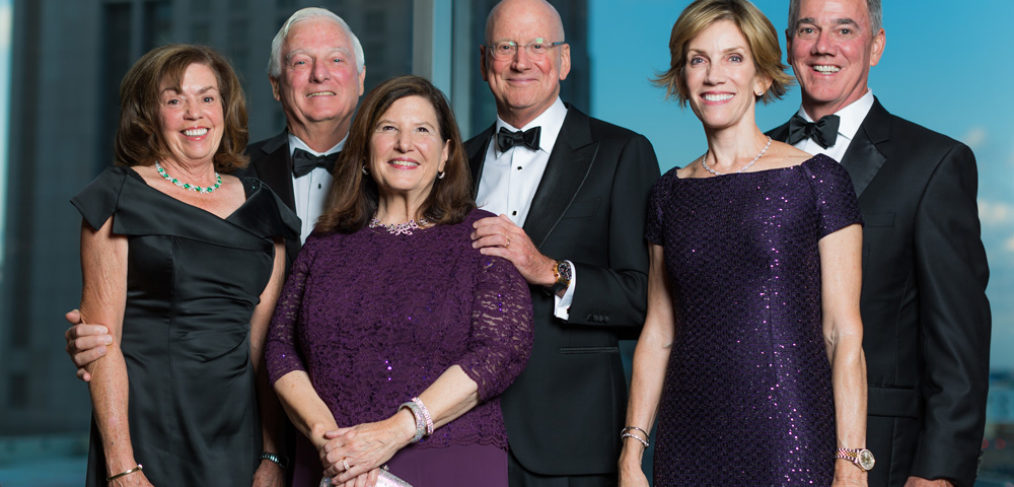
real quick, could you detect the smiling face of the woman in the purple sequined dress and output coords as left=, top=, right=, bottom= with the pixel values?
left=683, top=20, right=771, bottom=129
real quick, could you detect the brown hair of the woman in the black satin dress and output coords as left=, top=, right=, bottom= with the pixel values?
left=114, top=44, right=249, bottom=172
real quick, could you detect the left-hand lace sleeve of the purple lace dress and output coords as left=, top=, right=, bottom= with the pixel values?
left=264, top=238, right=314, bottom=384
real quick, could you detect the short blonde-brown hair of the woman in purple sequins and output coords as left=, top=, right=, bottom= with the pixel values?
left=654, top=0, right=792, bottom=107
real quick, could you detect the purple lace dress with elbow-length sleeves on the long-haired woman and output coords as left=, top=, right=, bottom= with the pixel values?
left=265, top=206, right=532, bottom=487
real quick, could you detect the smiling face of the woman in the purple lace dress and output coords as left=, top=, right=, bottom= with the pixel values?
left=369, top=95, right=450, bottom=208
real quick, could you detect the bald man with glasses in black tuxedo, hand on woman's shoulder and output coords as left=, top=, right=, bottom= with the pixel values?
left=465, top=0, right=658, bottom=487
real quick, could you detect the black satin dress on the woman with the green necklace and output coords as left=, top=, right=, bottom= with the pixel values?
left=72, top=167, right=298, bottom=487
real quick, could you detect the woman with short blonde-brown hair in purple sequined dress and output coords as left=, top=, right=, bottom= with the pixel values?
left=620, top=0, right=866, bottom=487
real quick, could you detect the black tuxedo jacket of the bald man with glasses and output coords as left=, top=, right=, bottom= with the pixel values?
left=465, top=107, right=659, bottom=476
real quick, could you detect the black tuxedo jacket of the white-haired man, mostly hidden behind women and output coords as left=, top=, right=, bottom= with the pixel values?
left=238, top=131, right=302, bottom=267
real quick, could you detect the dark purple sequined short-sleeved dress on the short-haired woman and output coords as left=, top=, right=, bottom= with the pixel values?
left=646, top=155, right=861, bottom=487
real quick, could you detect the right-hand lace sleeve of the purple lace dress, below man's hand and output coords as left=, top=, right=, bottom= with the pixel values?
left=458, top=256, right=533, bottom=402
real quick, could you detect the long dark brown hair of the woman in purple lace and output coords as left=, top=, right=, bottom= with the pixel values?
left=314, top=75, right=476, bottom=233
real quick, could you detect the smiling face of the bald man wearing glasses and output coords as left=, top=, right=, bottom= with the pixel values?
left=480, top=0, right=570, bottom=128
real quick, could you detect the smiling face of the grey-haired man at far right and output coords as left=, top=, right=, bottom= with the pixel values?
left=787, top=0, right=884, bottom=119
